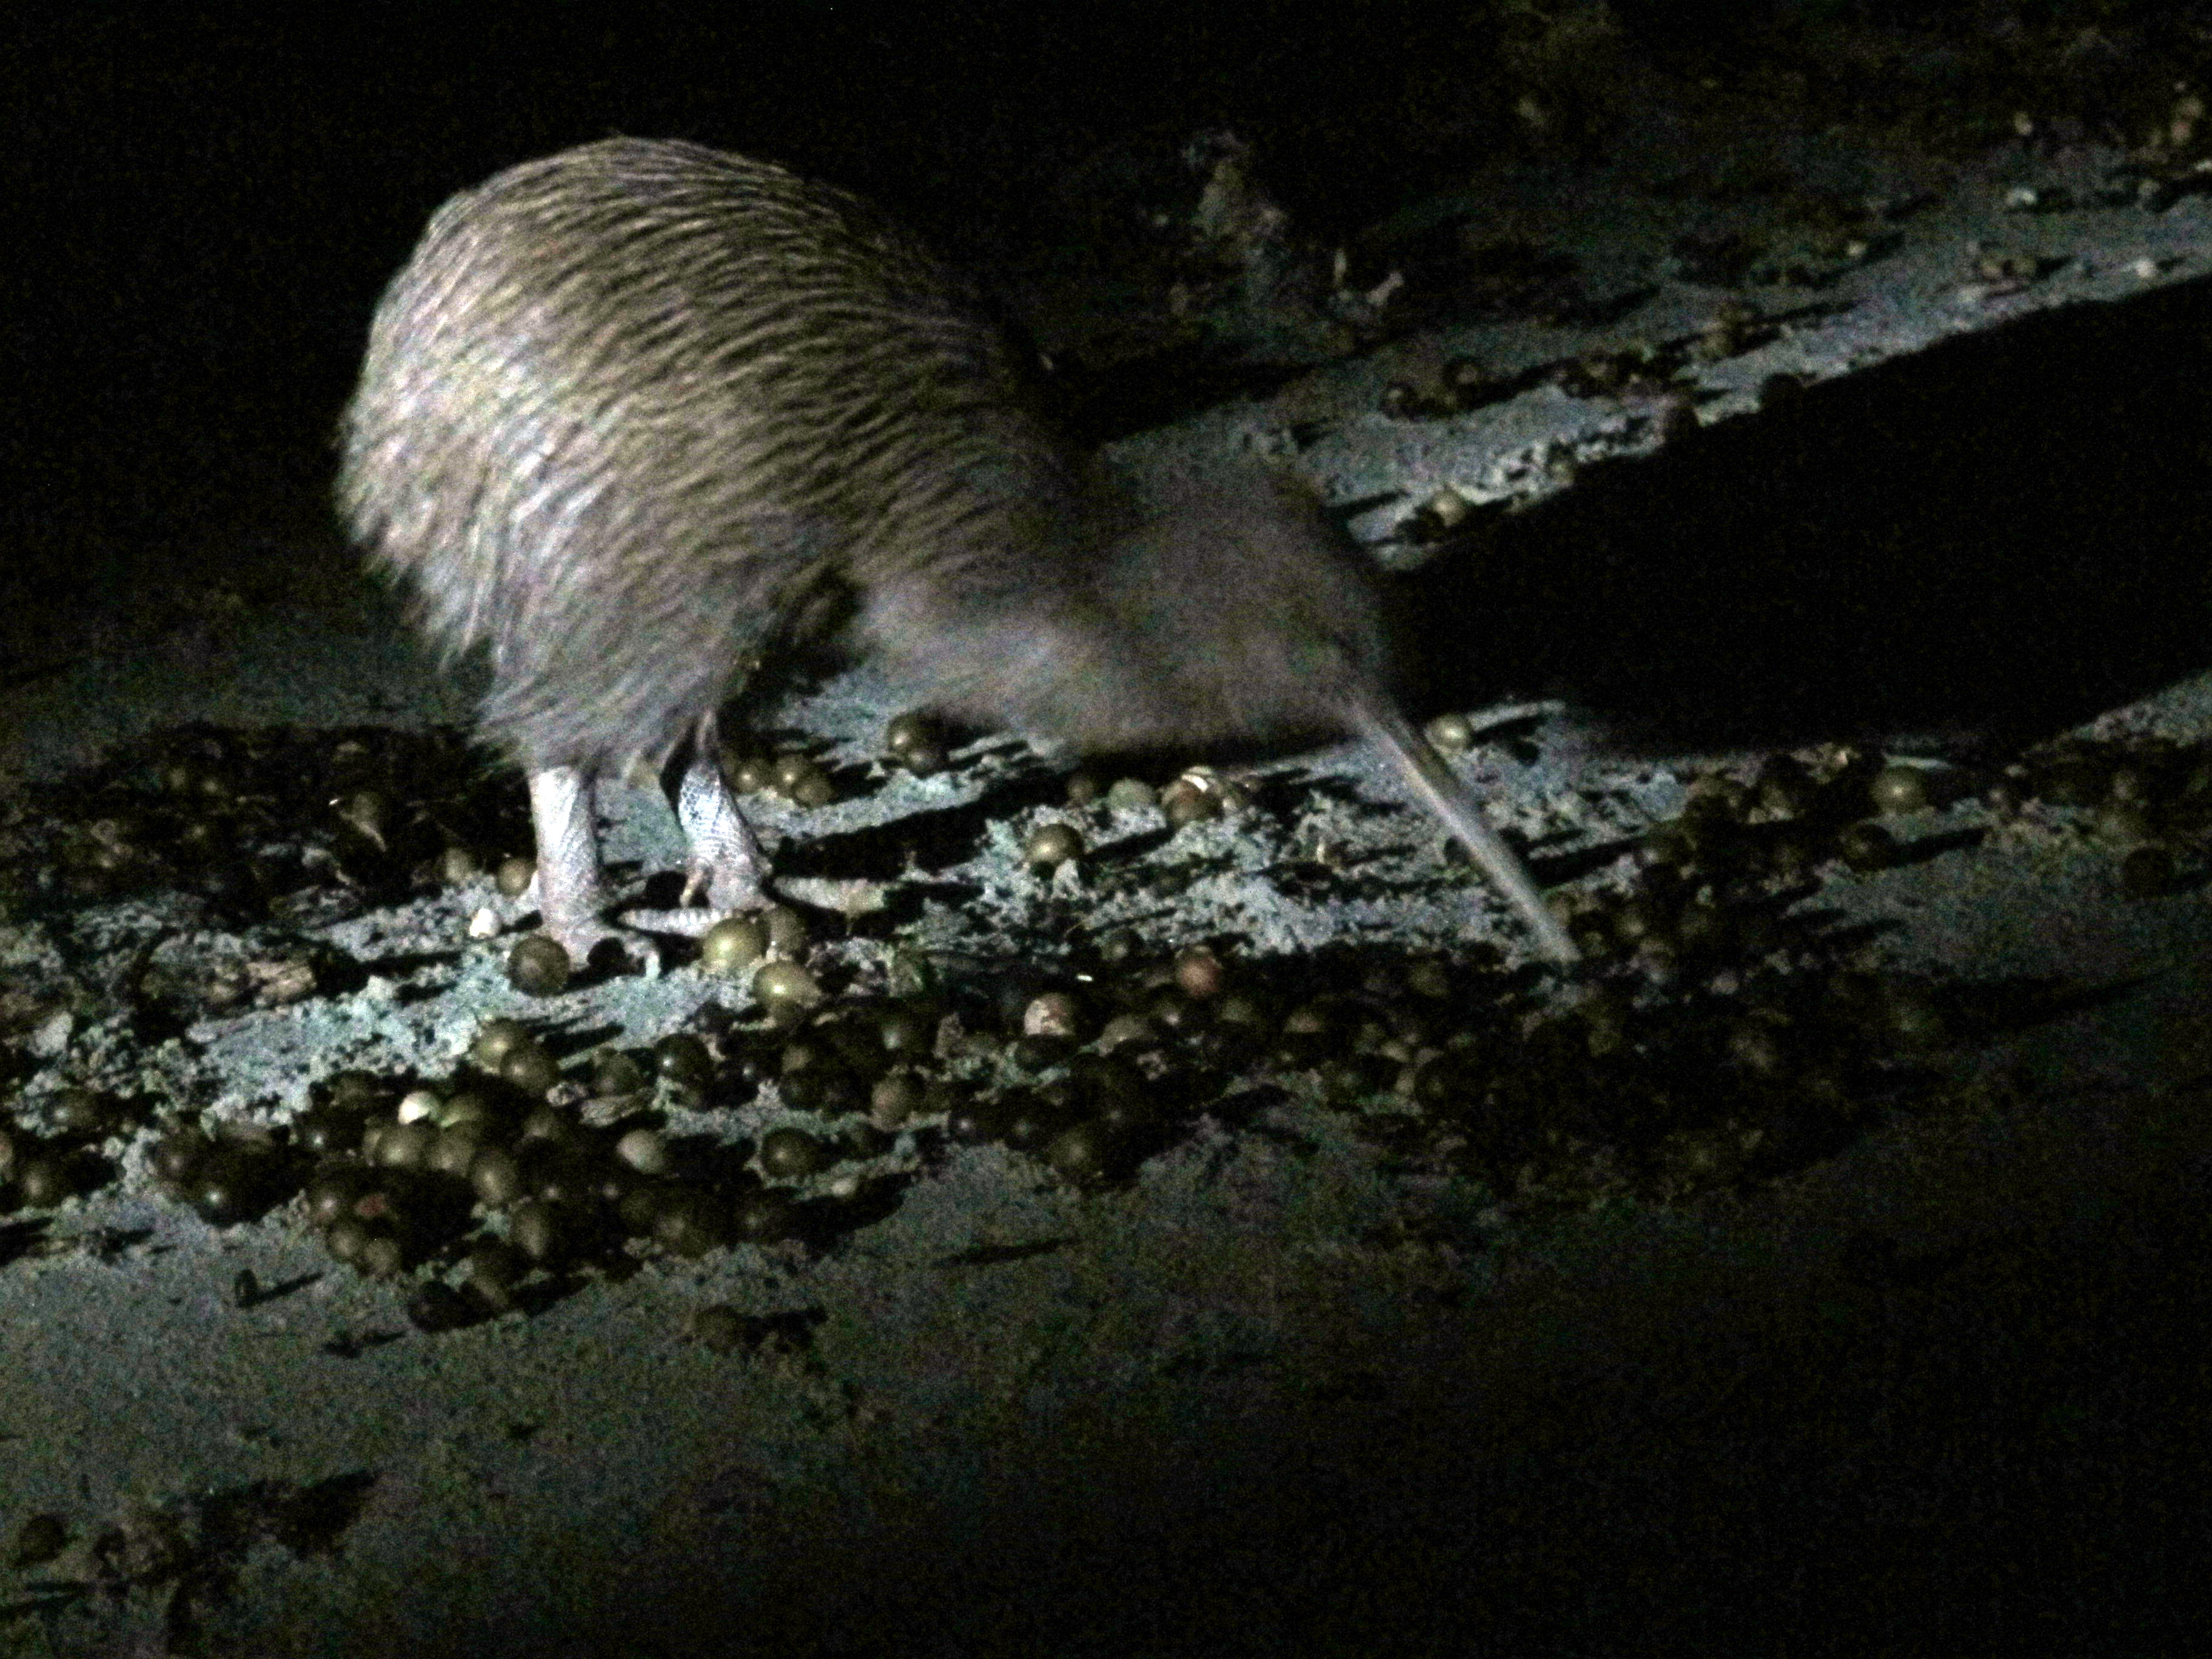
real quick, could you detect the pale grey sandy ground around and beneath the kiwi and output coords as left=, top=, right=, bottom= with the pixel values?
left=0, top=75, right=2212, bottom=1657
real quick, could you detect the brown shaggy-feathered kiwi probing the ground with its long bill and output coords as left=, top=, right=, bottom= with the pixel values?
left=338, top=139, right=1575, bottom=967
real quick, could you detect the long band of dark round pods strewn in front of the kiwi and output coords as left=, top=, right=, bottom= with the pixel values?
left=0, top=732, right=2212, bottom=1329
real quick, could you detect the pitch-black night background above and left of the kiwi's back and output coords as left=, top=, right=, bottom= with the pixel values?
left=4, top=4, right=1521, bottom=546
